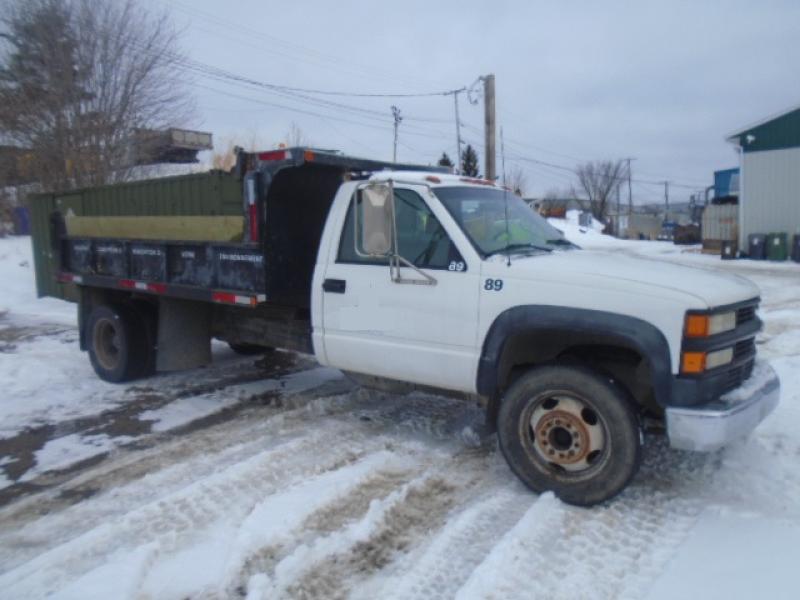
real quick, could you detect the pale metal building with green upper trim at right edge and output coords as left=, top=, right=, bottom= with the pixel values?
left=727, top=107, right=800, bottom=248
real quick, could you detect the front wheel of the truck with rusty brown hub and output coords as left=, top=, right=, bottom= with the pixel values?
left=497, top=366, right=641, bottom=506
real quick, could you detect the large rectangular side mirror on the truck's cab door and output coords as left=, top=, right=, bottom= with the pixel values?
left=354, top=183, right=394, bottom=257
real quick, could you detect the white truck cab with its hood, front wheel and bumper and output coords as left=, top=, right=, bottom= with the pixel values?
left=312, top=172, right=779, bottom=504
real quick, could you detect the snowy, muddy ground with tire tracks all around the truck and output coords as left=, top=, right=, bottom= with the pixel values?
left=0, top=226, right=800, bottom=600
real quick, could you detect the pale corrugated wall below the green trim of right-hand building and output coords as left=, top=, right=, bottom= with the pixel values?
left=739, top=148, right=800, bottom=248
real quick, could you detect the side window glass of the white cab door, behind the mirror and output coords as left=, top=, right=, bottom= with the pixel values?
left=337, top=189, right=466, bottom=271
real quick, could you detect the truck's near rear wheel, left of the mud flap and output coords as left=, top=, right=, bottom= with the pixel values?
left=86, top=305, right=150, bottom=383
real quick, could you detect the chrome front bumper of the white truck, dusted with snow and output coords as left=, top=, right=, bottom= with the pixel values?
left=666, top=363, right=781, bottom=452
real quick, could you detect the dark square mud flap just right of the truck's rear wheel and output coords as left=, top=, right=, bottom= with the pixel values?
left=156, top=298, right=211, bottom=371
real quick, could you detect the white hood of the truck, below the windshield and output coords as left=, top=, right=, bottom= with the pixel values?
left=500, top=250, right=759, bottom=308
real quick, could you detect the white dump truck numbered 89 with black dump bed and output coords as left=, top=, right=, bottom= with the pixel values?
left=32, top=148, right=779, bottom=505
